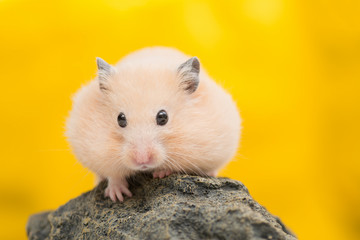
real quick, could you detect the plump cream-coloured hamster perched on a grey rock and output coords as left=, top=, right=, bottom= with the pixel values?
left=65, top=47, right=241, bottom=202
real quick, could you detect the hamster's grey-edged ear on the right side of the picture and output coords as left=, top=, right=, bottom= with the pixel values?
left=178, top=57, right=200, bottom=94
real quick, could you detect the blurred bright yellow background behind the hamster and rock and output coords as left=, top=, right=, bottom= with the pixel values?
left=0, top=0, right=360, bottom=239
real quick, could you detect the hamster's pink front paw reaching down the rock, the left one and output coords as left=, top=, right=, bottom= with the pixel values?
left=105, top=178, right=132, bottom=202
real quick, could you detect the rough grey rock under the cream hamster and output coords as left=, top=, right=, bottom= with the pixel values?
left=27, top=175, right=296, bottom=240
